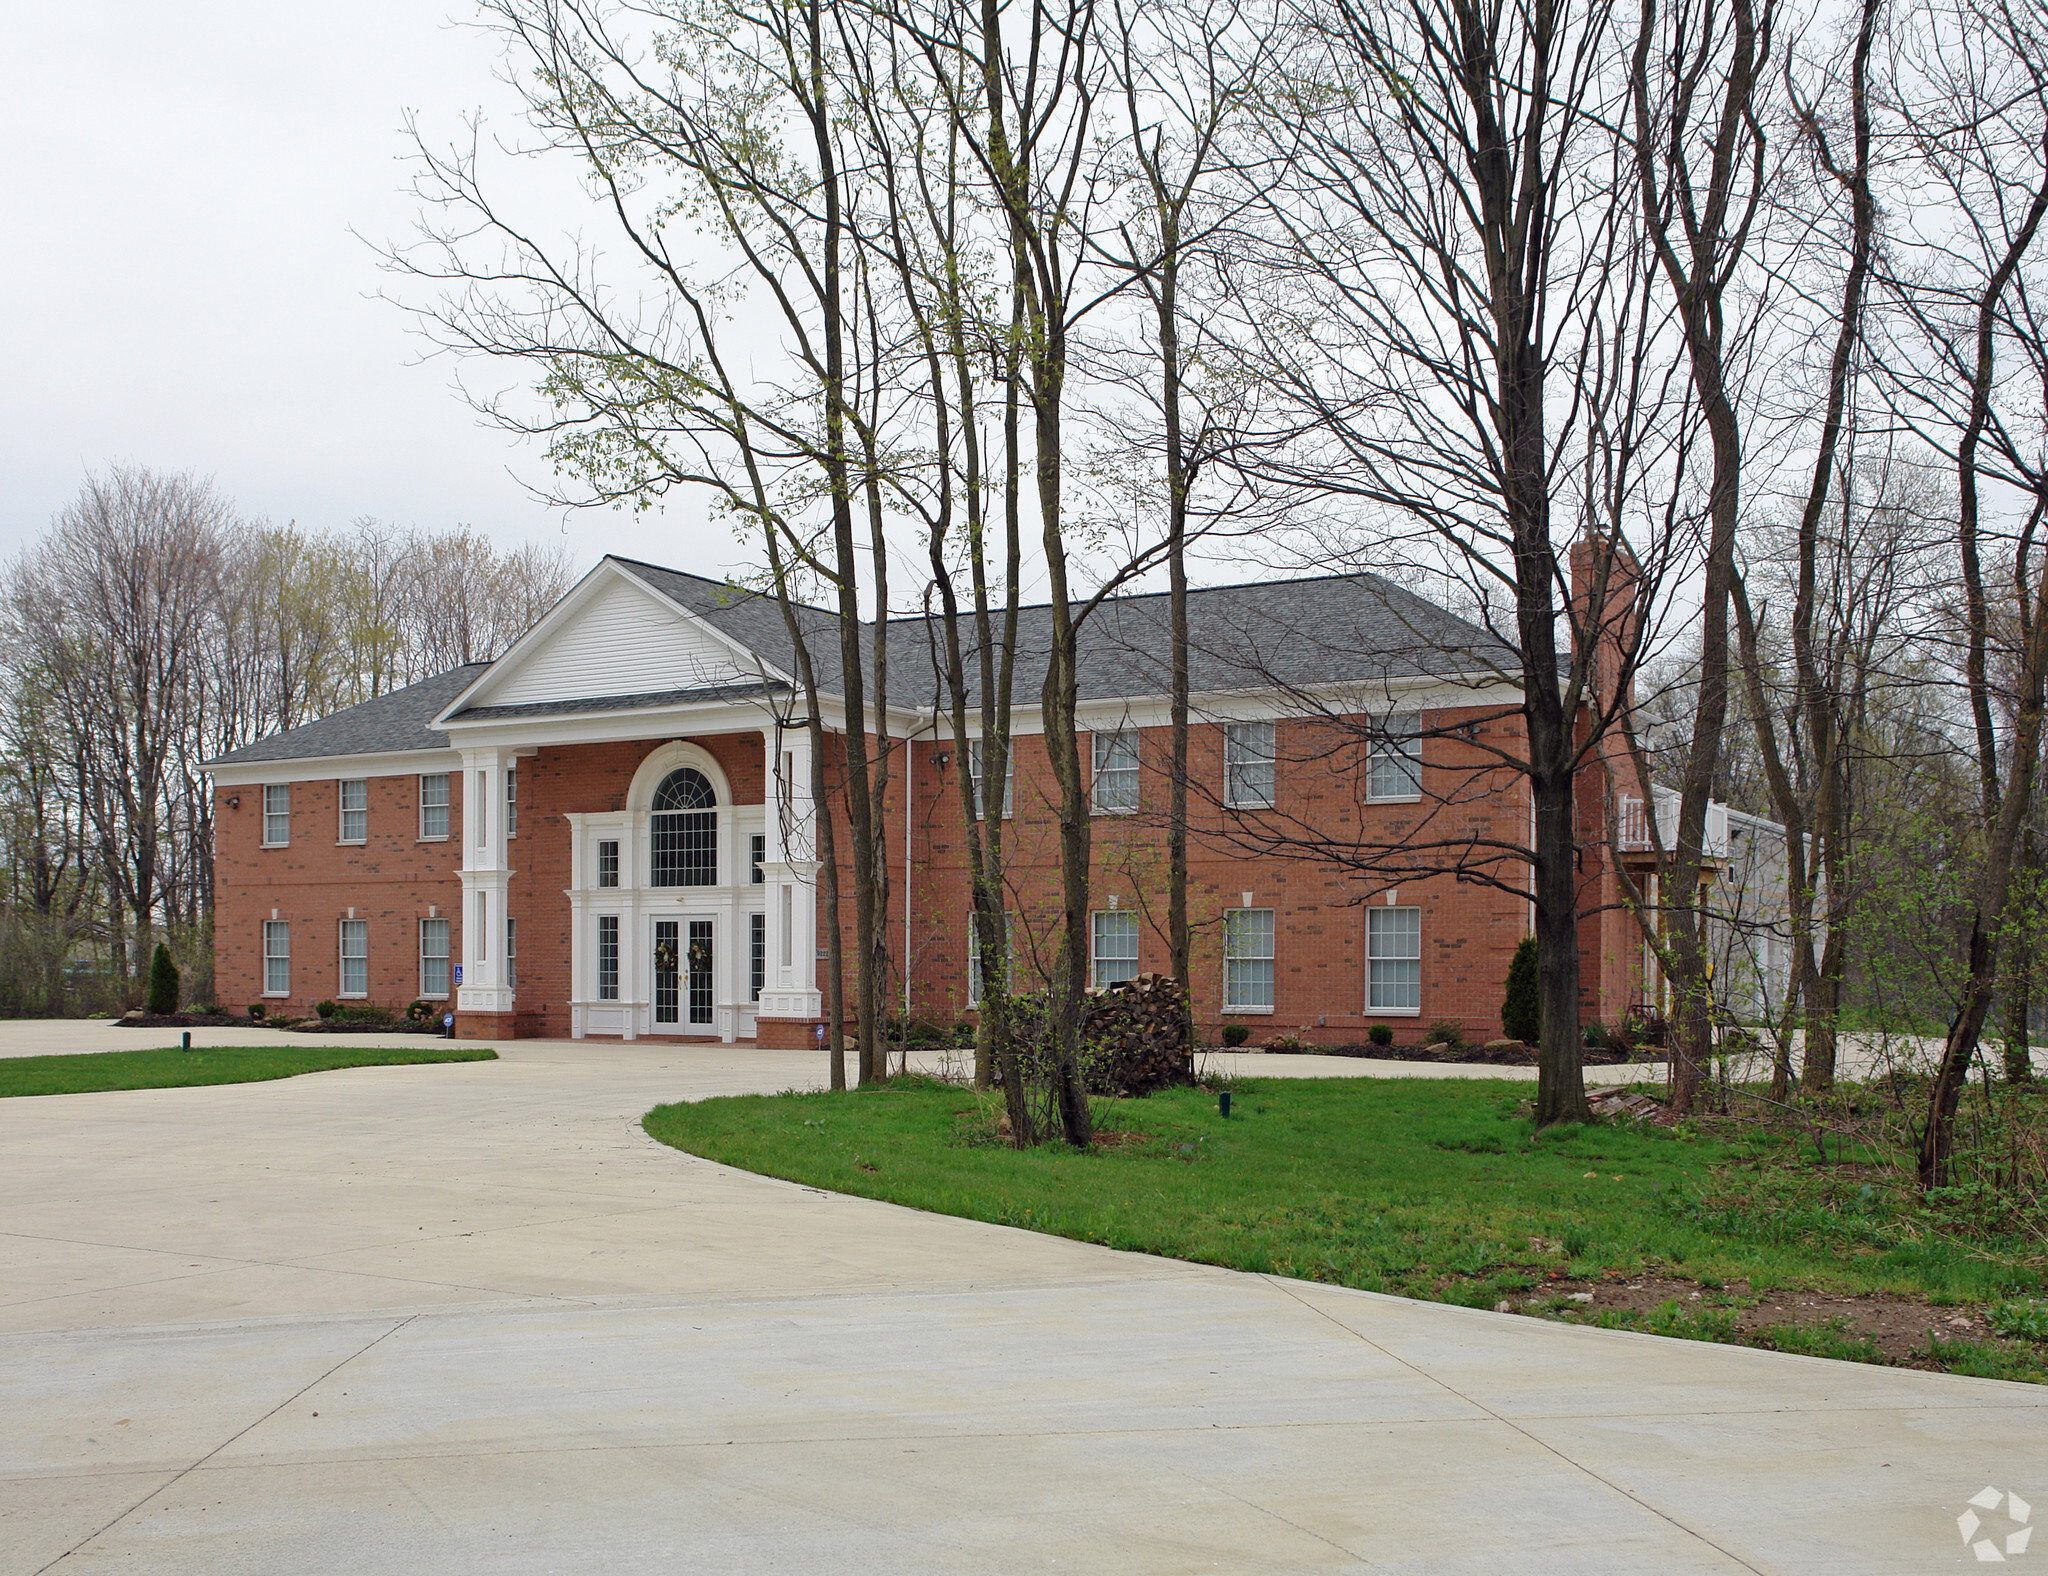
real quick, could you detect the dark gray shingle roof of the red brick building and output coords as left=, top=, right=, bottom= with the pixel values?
left=217, top=557, right=1516, bottom=765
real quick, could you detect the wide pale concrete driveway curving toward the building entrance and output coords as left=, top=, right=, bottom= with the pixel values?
left=0, top=1032, right=2048, bottom=1576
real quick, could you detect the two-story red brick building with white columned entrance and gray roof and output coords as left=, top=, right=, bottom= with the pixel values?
left=209, top=559, right=1642, bottom=1044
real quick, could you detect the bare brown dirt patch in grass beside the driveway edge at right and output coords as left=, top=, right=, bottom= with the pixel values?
left=1497, top=1271, right=2031, bottom=1369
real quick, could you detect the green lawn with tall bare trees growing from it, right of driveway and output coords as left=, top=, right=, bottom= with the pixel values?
left=645, top=1079, right=2042, bottom=1377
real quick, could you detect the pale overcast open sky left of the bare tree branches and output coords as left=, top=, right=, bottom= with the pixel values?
left=0, top=0, right=739, bottom=573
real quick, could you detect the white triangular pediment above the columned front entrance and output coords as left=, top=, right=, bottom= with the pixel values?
left=451, top=561, right=764, bottom=712
